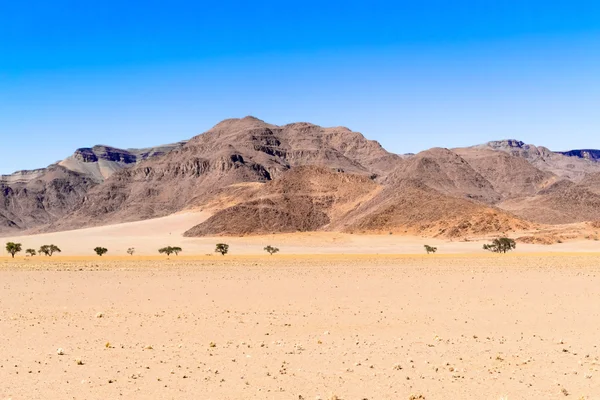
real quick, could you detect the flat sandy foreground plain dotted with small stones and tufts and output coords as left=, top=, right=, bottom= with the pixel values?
left=0, top=255, right=600, bottom=400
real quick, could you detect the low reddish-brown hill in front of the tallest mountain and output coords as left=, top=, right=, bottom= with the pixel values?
left=185, top=166, right=380, bottom=237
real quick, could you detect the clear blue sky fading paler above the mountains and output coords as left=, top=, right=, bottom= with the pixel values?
left=0, top=0, right=600, bottom=173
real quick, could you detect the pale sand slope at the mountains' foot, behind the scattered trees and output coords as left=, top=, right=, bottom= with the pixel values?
left=0, top=212, right=600, bottom=255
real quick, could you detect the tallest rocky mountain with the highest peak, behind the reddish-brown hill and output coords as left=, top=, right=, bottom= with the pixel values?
left=43, top=117, right=401, bottom=230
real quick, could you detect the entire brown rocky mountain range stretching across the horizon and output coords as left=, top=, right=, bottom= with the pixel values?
left=0, top=117, right=600, bottom=238
